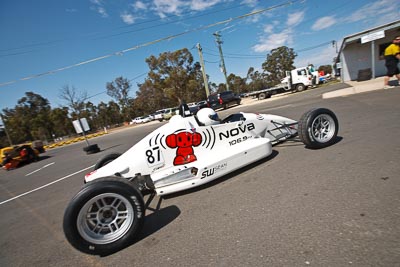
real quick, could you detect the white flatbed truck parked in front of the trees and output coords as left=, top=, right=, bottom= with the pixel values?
left=247, top=66, right=319, bottom=100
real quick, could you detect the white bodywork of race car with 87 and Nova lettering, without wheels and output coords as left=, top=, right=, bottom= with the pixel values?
left=85, top=113, right=297, bottom=195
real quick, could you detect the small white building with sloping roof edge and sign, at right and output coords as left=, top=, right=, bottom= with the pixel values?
left=336, top=20, right=400, bottom=82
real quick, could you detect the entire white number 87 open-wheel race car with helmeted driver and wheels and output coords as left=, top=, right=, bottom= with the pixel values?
left=63, top=108, right=339, bottom=255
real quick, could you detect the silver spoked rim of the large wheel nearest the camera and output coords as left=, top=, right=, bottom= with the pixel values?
left=77, top=193, right=134, bottom=244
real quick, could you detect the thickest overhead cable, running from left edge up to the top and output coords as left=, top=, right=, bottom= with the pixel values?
left=0, top=0, right=301, bottom=87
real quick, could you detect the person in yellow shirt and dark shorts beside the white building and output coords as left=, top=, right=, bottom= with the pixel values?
left=383, top=36, right=400, bottom=89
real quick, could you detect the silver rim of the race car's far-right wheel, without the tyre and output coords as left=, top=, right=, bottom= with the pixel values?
left=311, top=114, right=336, bottom=143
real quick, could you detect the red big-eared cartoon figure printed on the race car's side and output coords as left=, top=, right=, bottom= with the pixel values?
left=166, top=132, right=201, bottom=165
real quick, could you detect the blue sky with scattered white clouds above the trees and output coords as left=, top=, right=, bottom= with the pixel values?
left=0, top=0, right=400, bottom=111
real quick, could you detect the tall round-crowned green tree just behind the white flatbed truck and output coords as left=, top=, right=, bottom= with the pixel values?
left=262, top=46, right=297, bottom=85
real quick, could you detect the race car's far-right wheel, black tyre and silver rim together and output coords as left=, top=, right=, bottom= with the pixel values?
left=298, top=108, right=339, bottom=149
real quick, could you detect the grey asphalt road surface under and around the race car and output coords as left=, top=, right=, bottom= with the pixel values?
left=0, top=84, right=400, bottom=267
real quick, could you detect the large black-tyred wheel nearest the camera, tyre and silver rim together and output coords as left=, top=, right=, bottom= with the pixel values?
left=63, top=177, right=145, bottom=255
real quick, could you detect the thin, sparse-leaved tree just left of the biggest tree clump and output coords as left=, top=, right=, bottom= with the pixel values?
left=106, top=76, right=131, bottom=121
